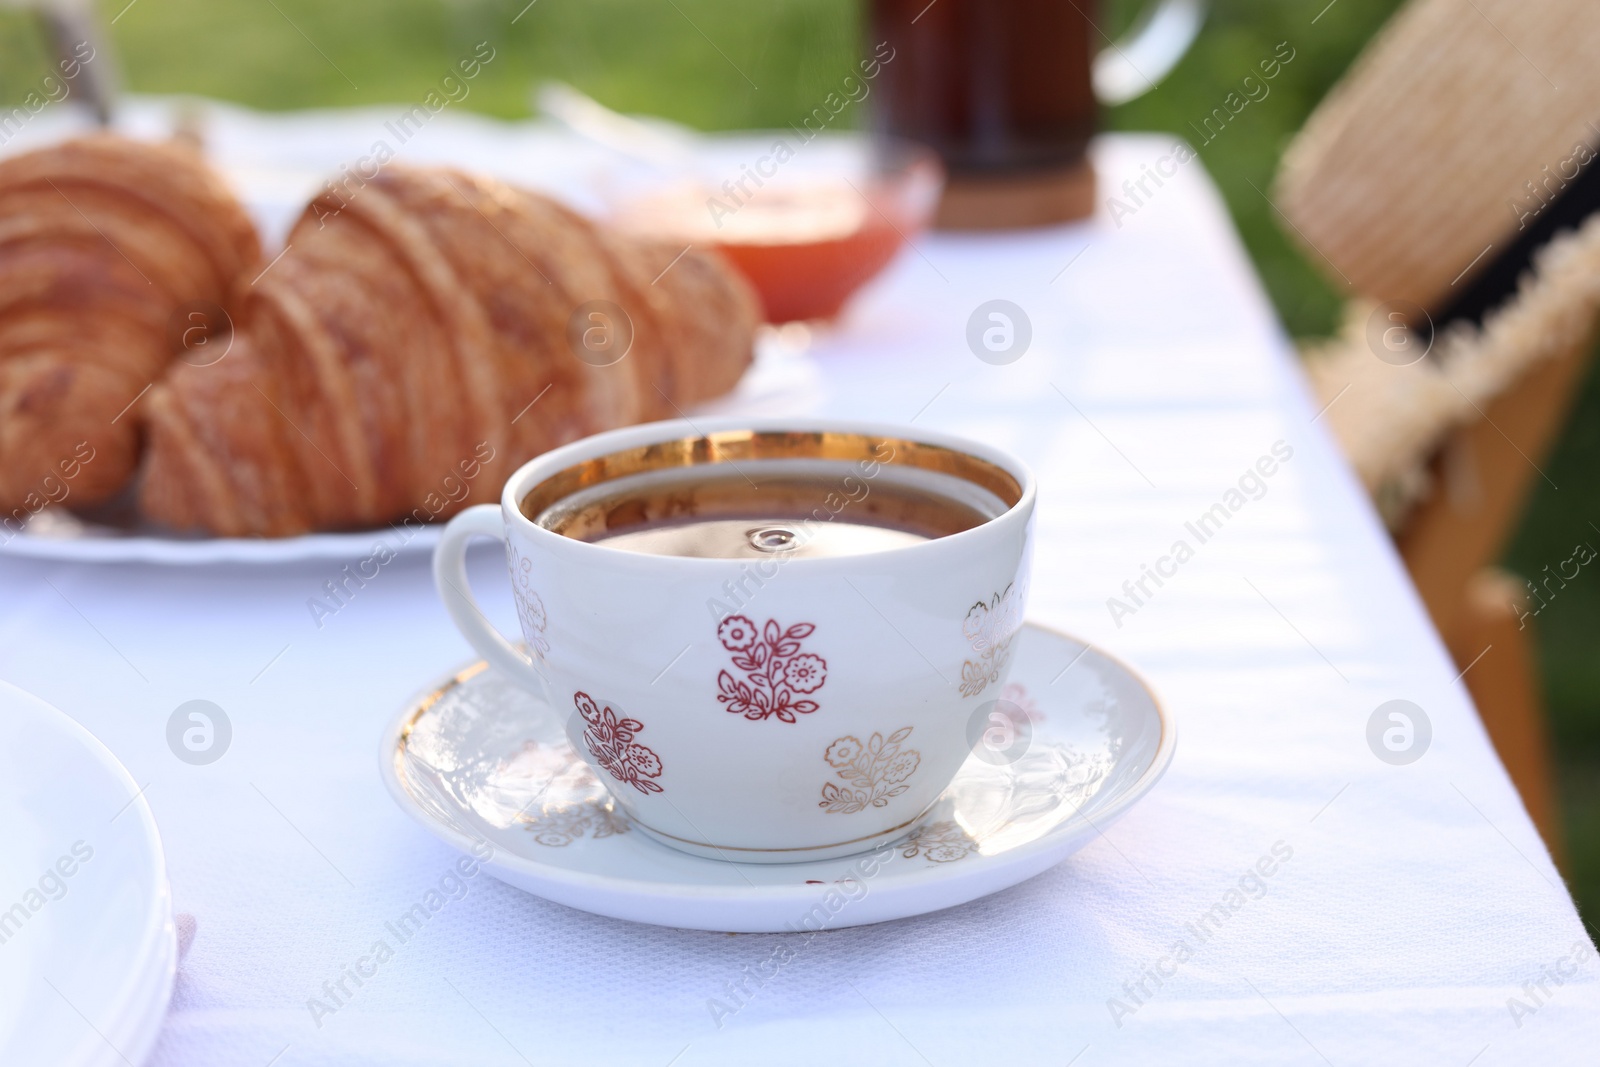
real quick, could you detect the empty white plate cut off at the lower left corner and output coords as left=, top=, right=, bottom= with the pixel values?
left=0, top=681, right=178, bottom=1067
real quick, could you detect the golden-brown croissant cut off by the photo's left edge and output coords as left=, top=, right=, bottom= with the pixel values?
left=0, top=136, right=259, bottom=531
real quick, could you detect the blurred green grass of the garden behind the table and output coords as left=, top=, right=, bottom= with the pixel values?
left=0, top=0, right=1600, bottom=920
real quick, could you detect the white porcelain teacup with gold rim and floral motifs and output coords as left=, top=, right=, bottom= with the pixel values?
left=434, top=419, right=1035, bottom=862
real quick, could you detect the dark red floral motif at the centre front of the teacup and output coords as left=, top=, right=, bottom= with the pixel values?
left=717, top=614, right=827, bottom=723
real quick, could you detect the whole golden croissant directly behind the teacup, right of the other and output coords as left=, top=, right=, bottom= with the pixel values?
left=139, top=166, right=758, bottom=536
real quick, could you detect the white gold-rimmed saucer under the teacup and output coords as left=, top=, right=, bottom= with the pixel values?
left=379, top=624, right=1176, bottom=933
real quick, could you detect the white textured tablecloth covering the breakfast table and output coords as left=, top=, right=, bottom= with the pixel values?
left=0, top=109, right=1600, bottom=1067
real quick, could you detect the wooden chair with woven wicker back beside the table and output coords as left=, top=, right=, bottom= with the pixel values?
left=1275, top=0, right=1600, bottom=859
